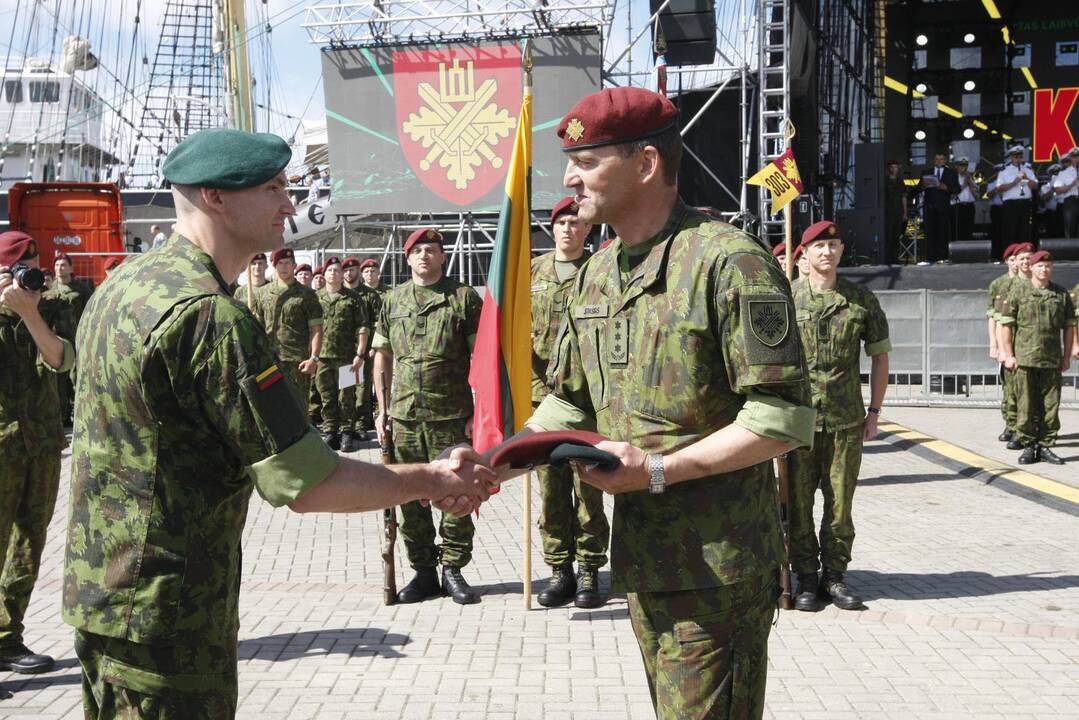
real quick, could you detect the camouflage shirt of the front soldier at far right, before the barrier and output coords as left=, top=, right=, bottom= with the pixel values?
left=1000, top=283, right=1076, bottom=368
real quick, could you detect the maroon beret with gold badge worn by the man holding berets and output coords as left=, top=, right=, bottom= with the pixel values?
left=558, top=87, right=678, bottom=152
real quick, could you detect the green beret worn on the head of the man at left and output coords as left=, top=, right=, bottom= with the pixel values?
left=161, top=127, right=292, bottom=190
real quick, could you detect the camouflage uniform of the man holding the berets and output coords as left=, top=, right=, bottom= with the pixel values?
left=529, top=203, right=814, bottom=719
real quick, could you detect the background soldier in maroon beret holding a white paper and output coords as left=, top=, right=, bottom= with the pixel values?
left=315, top=258, right=371, bottom=452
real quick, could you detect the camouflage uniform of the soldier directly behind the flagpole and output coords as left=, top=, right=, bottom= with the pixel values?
left=532, top=253, right=611, bottom=569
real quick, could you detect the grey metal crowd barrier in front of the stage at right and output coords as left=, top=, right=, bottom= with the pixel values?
left=861, top=290, right=1079, bottom=408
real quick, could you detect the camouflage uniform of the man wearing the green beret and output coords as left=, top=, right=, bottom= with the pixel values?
left=63, top=235, right=338, bottom=719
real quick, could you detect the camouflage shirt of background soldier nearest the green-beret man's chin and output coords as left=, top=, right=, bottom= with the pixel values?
left=251, top=280, right=321, bottom=363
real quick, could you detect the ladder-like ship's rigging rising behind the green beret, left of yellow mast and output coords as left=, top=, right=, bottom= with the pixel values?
left=128, top=0, right=229, bottom=188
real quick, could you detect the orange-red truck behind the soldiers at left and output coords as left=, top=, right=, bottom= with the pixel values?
left=8, top=182, right=124, bottom=286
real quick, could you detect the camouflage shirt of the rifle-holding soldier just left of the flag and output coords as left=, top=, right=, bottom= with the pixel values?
left=372, top=276, right=482, bottom=420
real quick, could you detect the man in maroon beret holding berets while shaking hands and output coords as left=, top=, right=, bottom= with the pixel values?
left=500, top=87, right=815, bottom=720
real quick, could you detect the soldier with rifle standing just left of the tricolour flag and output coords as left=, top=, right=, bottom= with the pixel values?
left=371, top=228, right=482, bottom=604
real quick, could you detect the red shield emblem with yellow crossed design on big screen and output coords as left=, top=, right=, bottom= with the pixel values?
left=394, top=43, right=521, bottom=206
